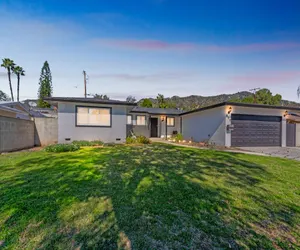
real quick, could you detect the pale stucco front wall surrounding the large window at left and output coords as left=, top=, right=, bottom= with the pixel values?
left=58, top=102, right=127, bottom=143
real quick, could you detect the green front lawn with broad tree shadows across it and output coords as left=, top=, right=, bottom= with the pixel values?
left=0, top=144, right=300, bottom=249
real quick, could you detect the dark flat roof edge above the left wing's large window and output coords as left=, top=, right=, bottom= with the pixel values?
left=44, top=97, right=137, bottom=106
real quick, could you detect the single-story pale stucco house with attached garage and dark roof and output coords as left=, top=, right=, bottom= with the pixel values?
left=45, top=97, right=300, bottom=147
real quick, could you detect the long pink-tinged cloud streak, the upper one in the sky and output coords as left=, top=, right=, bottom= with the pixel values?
left=91, top=39, right=300, bottom=53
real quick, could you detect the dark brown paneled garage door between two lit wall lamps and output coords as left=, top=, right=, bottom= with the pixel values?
left=231, top=114, right=281, bottom=147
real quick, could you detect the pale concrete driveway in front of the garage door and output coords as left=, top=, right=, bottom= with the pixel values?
left=240, top=147, right=300, bottom=161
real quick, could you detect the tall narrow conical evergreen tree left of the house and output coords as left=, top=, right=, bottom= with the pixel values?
left=38, top=61, right=53, bottom=108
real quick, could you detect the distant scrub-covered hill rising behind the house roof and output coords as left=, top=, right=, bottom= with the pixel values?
left=138, top=91, right=300, bottom=110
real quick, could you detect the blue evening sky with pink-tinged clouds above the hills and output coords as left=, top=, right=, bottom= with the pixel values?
left=0, top=0, right=300, bottom=101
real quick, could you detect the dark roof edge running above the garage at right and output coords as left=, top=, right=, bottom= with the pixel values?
left=181, top=102, right=300, bottom=115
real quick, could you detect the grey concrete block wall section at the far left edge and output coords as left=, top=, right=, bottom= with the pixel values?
left=0, top=116, right=34, bottom=153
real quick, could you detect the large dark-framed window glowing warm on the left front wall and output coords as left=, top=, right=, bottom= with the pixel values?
left=76, top=107, right=111, bottom=127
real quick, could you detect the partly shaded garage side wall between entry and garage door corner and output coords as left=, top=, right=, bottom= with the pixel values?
left=182, top=106, right=226, bottom=145
